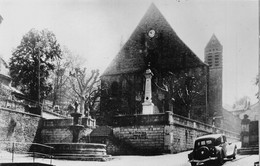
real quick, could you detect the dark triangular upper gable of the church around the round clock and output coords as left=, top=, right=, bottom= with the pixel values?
left=103, top=4, right=205, bottom=76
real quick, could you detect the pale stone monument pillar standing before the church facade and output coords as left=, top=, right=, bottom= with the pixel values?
left=142, top=69, right=154, bottom=114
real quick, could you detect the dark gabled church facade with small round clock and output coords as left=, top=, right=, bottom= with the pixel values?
left=97, top=4, right=214, bottom=124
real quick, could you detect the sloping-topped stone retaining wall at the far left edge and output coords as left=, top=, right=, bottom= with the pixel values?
left=0, top=107, right=41, bottom=151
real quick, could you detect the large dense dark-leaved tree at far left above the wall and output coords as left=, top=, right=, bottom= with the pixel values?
left=10, top=29, right=61, bottom=101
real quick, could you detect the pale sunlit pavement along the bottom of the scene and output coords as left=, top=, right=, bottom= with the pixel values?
left=0, top=141, right=259, bottom=166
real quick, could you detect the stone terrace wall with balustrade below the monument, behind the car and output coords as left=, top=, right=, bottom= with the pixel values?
left=108, top=112, right=240, bottom=154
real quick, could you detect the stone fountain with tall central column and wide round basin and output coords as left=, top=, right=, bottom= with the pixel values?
left=46, top=102, right=111, bottom=161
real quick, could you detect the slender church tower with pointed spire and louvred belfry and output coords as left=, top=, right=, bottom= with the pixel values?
left=204, top=34, right=223, bottom=127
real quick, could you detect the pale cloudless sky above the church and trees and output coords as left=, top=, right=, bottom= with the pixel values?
left=0, top=0, right=259, bottom=105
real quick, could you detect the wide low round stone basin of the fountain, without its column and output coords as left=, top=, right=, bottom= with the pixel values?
left=46, top=143, right=111, bottom=161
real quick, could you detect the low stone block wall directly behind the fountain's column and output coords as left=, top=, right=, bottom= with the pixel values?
left=41, top=118, right=96, bottom=143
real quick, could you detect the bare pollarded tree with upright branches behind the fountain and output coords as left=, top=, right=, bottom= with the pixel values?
left=70, top=68, right=99, bottom=116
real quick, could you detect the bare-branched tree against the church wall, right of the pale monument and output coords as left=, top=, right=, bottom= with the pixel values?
left=157, top=68, right=206, bottom=118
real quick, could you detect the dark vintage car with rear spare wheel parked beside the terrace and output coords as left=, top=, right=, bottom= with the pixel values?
left=188, top=134, right=237, bottom=166
